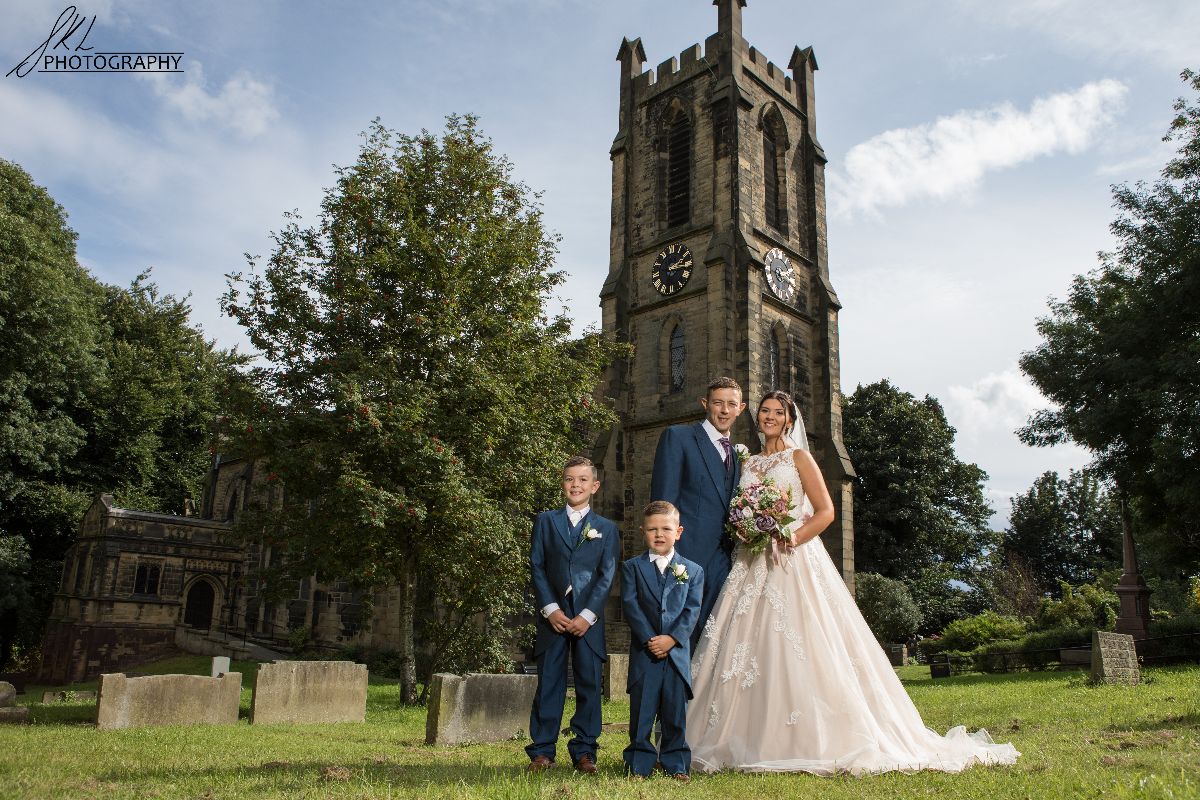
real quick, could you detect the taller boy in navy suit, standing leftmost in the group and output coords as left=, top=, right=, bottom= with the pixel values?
left=526, top=456, right=620, bottom=772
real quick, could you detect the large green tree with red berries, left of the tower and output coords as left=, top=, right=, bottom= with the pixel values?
left=222, top=116, right=618, bottom=702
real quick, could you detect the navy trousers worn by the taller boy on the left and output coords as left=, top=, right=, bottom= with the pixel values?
left=526, top=597, right=604, bottom=764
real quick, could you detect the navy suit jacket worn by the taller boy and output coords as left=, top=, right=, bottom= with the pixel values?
left=529, top=507, right=620, bottom=660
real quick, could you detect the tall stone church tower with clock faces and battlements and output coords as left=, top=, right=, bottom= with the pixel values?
left=595, top=0, right=854, bottom=644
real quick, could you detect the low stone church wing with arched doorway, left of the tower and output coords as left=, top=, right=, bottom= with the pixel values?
left=38, top=456, right=398, bottom=684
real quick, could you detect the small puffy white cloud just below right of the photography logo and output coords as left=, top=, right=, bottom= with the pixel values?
left=145, top=60, right=280, bottom=138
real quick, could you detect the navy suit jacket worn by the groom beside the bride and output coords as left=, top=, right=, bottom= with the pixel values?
left=650, top=422, right=742, bottom=569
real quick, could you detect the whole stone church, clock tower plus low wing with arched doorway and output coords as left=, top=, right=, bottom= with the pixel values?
left=38, top=0, right=854, bottom=684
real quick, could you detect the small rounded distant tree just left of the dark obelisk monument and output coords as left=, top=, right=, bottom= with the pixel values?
left=1003, top=470, right=1121, bottom=594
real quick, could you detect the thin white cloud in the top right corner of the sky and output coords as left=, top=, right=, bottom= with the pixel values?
left=965, top=0, right=1200, bottom=71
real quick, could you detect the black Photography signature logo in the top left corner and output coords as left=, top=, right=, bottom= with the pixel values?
left=5, top=6, right=184, bottom=78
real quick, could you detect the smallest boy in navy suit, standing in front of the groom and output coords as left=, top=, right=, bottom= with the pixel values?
left=620, top=500, right=704, bottom=782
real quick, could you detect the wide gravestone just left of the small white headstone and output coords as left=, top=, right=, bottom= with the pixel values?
left=96, top=672, right=241, bottom=730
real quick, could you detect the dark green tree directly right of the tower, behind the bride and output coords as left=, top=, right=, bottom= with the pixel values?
left=842, top=380, right=996, bottom=633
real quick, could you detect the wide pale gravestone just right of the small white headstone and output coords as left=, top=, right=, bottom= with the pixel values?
left=250, top=661, right=367, bottom=724
